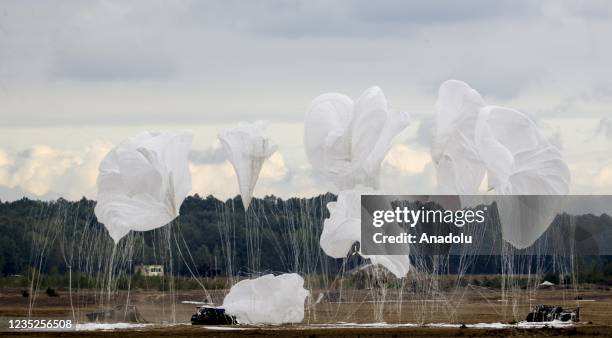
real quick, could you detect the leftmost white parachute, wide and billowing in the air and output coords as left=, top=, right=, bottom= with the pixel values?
left=95, top=132, right=192, bottom=243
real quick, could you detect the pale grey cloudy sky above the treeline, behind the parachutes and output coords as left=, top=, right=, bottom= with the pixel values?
left=0, top=0, right=612, bottom=200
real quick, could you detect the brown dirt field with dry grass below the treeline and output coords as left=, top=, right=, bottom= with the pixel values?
left=0, top=287, right=612, bottom=337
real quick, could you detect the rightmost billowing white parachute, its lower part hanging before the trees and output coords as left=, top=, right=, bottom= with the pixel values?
left=475, top=106, right=570, bottom=249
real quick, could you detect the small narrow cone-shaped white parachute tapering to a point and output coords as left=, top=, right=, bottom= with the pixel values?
left=219, top=121, right=276, bottom=210
